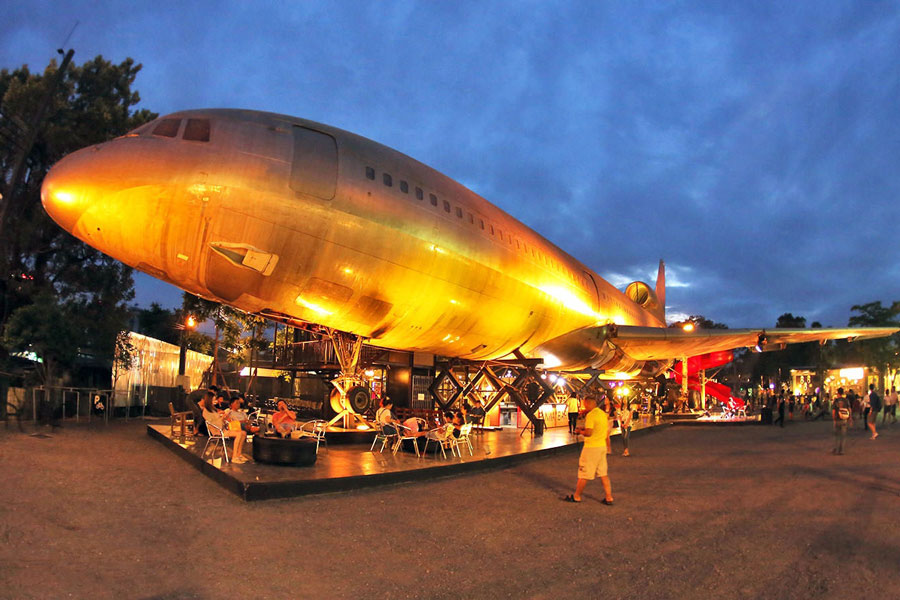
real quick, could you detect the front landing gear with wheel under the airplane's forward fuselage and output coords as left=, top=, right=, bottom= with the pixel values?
left=328, top=330, right=372, bottom=429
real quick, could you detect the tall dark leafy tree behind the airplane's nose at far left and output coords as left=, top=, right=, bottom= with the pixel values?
left=0, top=56, right=156, bottom=379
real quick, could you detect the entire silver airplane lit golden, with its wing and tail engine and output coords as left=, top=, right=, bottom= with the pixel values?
left=42, top=110, right=897, bottom=396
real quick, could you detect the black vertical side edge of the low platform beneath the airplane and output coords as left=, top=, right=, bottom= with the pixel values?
left=147, top=423, right=669, bottom=502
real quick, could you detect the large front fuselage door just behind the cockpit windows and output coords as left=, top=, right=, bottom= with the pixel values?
left=290, top=125, right=337, bottom=200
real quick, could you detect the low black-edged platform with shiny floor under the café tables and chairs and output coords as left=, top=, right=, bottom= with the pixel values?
left=147, top=421, right=664, bottom=501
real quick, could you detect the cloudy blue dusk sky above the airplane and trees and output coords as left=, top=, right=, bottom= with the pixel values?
left=0, top=0, right=900, bottom=327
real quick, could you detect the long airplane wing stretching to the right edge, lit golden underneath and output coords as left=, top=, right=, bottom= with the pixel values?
left=533, top=324, right=900, bottom=370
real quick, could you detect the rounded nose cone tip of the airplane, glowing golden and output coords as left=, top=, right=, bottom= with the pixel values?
left=41, top=148, right=99, bottom=233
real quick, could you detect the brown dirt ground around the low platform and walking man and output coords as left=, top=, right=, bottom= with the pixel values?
left=0, top=421, right=900, bottom=600
